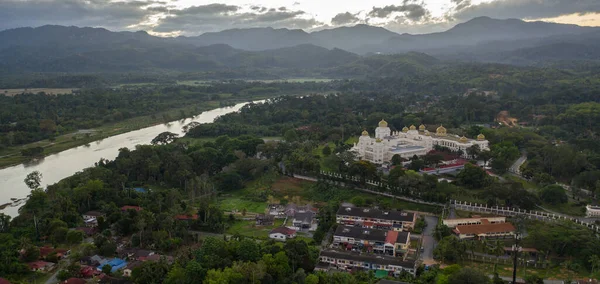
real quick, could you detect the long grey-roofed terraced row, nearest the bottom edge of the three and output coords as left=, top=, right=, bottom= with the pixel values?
left=319, top=250, right=417, bottom=275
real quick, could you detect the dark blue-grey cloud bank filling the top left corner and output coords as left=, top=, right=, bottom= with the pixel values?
left=0, top=0, right=161, bottom=30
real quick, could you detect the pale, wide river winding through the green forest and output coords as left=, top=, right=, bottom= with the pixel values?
left=0, top=100, right=263, bottom=217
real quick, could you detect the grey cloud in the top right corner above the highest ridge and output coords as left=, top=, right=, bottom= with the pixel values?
left=453, top=0, right=600, bottom=21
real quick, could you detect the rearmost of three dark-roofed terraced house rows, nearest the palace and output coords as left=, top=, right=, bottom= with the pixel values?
left=336, top=206, right=417, bottom=231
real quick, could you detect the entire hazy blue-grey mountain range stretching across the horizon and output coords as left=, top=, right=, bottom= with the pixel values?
left=0, top=17, right=600, bottom=76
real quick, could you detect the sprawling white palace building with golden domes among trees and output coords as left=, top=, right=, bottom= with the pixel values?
left=352, top=119, right=489, bottom=164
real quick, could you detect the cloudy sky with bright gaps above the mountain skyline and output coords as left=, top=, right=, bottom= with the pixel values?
left=0, top=0, right=600, bottom=36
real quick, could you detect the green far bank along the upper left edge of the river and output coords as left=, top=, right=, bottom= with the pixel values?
left=0, top=96, right=271, bottom=169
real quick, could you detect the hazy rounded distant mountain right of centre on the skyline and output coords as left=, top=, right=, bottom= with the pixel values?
left=311, top=25, right=398, bottom=51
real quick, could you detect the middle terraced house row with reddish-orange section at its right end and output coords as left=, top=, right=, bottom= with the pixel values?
left=333, top=226, right=410, bottom=256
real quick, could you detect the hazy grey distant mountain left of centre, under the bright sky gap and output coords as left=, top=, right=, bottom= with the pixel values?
left=178, top=28, right=314, bottom=51
